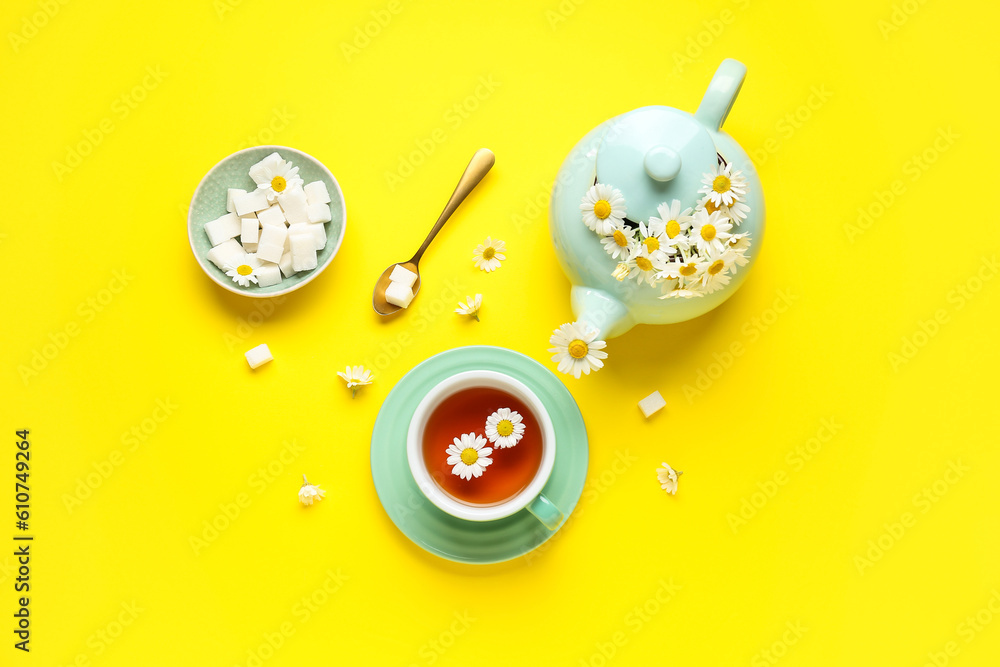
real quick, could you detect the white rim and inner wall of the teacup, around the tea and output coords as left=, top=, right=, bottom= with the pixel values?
left=406, top=371, right=556, bottom=521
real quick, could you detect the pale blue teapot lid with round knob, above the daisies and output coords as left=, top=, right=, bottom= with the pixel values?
left=597, top=106, right=718, bottom=221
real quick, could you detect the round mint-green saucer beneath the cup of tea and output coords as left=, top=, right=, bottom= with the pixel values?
left=372, top=345, right=589, bottom=563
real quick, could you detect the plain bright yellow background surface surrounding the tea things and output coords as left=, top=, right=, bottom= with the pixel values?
left=0, top=0, right=1000, bottom=666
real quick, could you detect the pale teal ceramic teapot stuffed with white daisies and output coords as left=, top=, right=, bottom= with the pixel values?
left=549, top=59, right=764, bottom=339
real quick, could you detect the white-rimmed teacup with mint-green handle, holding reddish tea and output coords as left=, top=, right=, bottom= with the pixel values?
left=406, top=370, right=563, bottom=530
